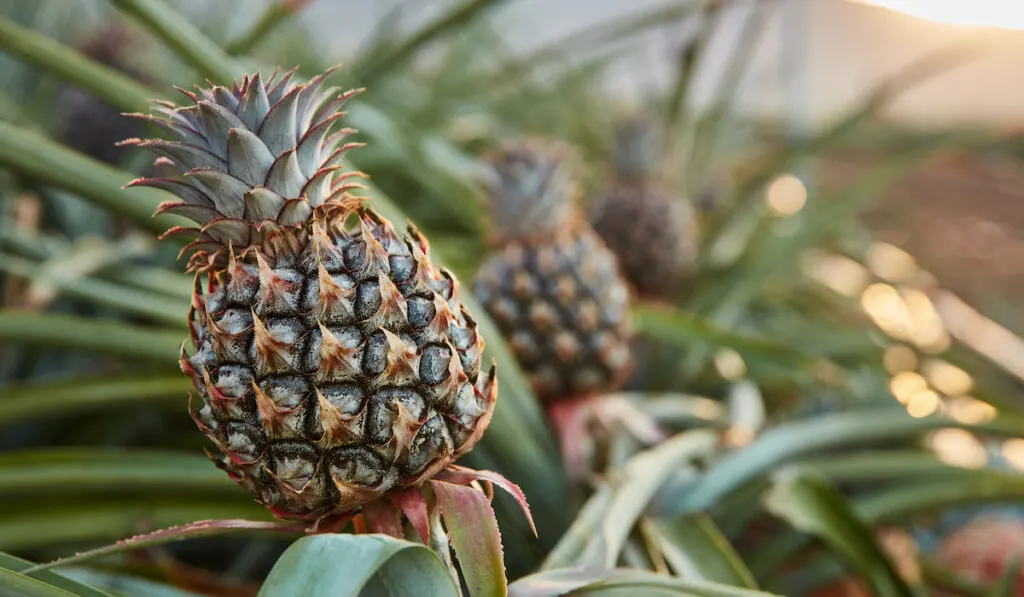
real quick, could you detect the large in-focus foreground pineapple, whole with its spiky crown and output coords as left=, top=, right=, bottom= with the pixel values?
left=129, top=73, right=497, bottom=521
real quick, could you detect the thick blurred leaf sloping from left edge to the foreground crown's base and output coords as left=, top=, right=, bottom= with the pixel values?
left=0, top=122, right=188, bottom=232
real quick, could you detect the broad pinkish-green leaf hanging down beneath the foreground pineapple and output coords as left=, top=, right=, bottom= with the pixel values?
left=430, top=481, right=508, bottom=597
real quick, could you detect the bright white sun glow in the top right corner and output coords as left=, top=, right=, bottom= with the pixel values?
left=859, top=0, right=1024, bottom=29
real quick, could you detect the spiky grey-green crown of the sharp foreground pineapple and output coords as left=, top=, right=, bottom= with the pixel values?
left=122, top=69, right=365, bottom=270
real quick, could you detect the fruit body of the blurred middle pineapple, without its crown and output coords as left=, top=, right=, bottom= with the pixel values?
left=476, top=228, right=631, bottom=400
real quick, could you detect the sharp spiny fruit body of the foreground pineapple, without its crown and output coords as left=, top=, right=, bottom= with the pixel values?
left=182, top=212, right=495, bottom=518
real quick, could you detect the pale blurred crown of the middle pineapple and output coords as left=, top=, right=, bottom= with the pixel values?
left=482, top=138, right=579, bottom=241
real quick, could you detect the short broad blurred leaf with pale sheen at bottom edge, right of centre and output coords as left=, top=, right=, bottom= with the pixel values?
left=645, top=514, right=758, bottom=589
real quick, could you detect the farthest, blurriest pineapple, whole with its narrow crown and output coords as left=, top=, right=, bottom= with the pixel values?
left=589, top=118, right=697, bottom=298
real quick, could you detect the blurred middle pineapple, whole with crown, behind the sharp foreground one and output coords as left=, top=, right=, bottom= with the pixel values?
left=475, top=140, right=632, bottom=401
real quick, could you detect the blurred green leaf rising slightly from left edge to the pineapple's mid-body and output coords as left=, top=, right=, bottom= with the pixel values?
left=0, top=372, right=193, bottom=424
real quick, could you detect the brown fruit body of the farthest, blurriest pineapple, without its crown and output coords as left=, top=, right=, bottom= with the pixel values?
left=589, top=183, right=698, bottom=297
